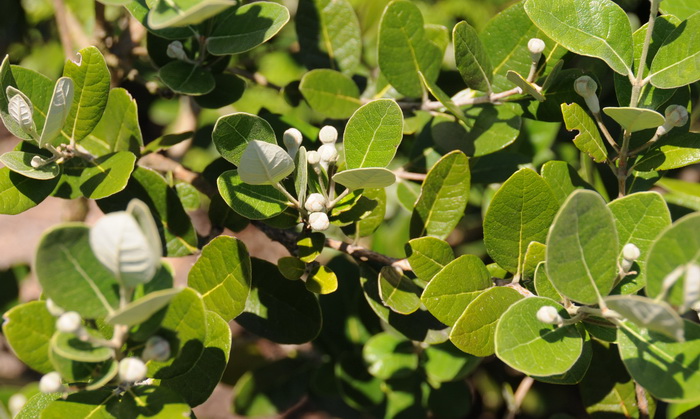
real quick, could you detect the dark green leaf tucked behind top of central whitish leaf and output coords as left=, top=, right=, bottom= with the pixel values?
left=212, top=112, right=277, bottom=165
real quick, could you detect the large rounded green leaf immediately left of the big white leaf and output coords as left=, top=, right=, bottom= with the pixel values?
left=35, top=223, right=119, bottom=318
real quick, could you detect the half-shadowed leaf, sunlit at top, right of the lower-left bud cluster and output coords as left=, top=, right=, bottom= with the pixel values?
left=160, top=310, right=231, bottom=406
